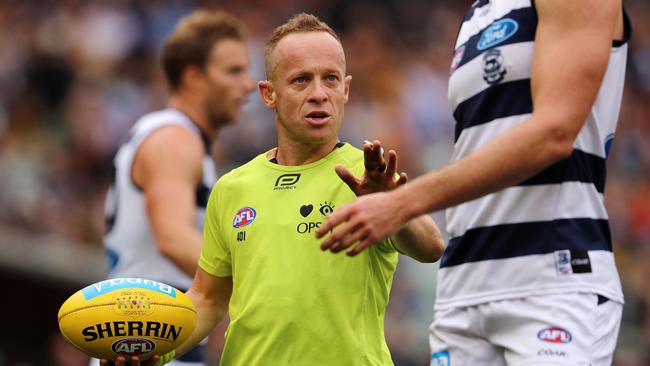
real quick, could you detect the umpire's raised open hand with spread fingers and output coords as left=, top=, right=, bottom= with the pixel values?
left=335, top=140, right=408, bottom=196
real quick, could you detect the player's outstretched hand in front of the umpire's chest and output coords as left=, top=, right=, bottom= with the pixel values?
left=316, top=192, right=408, bottom=256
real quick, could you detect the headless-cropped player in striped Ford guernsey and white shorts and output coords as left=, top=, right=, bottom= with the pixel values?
left=317, top=0, right=630, bottom=366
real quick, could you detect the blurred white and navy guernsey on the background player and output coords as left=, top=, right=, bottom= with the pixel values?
left=104, top=108, right=217, bottom=290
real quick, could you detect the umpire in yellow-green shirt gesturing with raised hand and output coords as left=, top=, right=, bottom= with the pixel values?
left=156, top=14, right=443, bottom=366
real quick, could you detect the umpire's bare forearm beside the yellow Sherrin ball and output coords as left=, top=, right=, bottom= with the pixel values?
left=175, top=267, right=232, bottom=356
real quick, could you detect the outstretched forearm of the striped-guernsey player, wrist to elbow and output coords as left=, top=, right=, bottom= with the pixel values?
left=394, top=119, right=574, bottom=222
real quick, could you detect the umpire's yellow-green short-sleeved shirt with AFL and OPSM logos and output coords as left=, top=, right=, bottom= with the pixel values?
left=199, top=144, right=397, bottom=366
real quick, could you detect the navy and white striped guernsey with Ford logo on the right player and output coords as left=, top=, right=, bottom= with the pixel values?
left=436, top=0, right=630, bottom=309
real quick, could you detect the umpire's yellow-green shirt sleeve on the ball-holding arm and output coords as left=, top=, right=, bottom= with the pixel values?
left=199, top=182, right=232, bottom=277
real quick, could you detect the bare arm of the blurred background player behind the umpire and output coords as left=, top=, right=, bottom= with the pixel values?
left=131, top=126, right=205, bottom=276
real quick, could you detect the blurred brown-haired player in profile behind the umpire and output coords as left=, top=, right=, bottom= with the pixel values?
left=98, top=11, right=254, bottom=365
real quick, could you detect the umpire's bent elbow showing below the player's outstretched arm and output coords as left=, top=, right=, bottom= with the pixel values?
left=392, top=215, right=444, bottom=263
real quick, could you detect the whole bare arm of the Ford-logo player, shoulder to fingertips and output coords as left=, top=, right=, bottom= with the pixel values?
left=318, top=0, right=622, bottom=247
